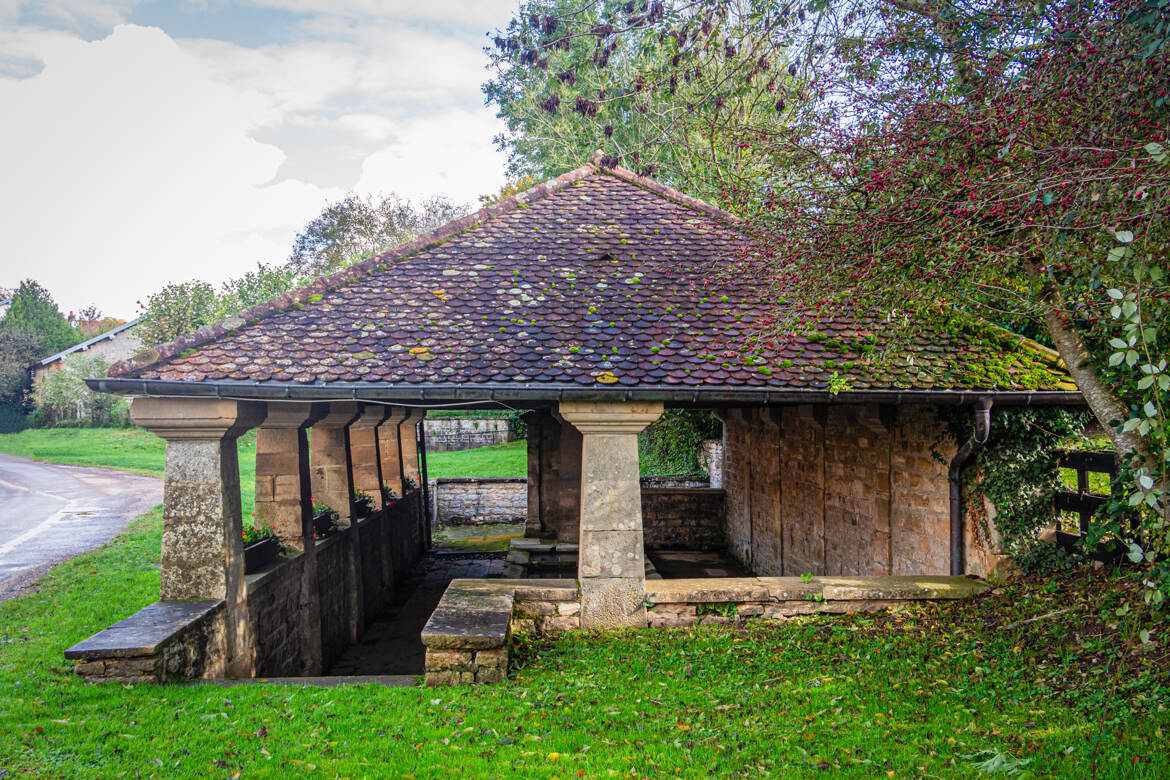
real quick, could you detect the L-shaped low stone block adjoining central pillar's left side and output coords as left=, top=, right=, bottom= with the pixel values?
left=422, top=580, right=580, bottom=685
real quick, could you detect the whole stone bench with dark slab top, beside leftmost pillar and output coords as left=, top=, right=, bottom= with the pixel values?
left=66, top=600, right=225, bottom=683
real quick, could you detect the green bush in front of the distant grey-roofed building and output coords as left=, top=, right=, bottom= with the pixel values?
left=33, top=353, right=130, bottom=428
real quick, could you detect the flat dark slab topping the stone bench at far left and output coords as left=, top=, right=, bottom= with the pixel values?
left=66, top=599, right=223, bottom=661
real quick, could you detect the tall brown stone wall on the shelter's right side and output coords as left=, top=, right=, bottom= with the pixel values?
left=723, top=403, right=954, bottom=575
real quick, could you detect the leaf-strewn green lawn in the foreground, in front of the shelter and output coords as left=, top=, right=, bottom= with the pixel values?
left=0, top=511, right=1170, bottom=779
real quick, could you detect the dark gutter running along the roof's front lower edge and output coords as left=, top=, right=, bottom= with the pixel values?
left=85, top=378, right=1085, bottom=406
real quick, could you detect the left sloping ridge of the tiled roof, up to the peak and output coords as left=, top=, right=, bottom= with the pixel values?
left=108, top=163, right=599, bottom=378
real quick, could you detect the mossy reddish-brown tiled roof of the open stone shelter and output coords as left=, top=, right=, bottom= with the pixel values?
left=111, top=165, right=1072, bottom=391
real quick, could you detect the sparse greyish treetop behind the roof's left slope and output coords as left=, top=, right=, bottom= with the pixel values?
left=288, top=193, right=469, bottom=277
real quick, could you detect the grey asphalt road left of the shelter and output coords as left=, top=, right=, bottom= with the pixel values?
left=0, top=453, right=163, bottom=600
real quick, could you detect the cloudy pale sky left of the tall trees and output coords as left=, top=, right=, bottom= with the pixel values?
left=0, top=0, right=517, bottom=318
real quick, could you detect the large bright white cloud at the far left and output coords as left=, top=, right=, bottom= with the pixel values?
left=0, top=26, right=340, bottom=316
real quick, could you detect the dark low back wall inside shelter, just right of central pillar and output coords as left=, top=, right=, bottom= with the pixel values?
left=642, top=485, right=727, bottom=550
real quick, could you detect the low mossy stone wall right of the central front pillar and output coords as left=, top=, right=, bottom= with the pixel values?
left=646, top=575, right=989, bottom=627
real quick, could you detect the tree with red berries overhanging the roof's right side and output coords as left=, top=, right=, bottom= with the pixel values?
left=504, top=0, right=1170, bottom=580
